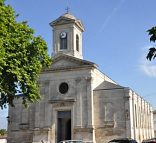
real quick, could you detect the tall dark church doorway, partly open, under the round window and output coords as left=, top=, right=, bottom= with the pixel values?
left=57, top=111, right=71, bottom=142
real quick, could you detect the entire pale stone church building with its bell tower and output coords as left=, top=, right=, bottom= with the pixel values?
left=8, top=13, right=154, bottom=143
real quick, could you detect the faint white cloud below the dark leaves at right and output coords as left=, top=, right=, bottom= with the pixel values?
left=139, top=45, right=156, bottom=77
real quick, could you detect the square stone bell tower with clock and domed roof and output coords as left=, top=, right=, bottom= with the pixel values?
left=50, top=12, right=84, bottom=59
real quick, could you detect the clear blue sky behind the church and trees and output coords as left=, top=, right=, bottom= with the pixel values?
left=0, top=0, right=156, bottom=128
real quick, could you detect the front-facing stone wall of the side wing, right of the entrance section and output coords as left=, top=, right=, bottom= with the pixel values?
left=94, top=89, right=126, bottom=143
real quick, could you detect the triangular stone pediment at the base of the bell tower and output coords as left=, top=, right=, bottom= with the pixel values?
left=47, top=54, right=97, bottom=70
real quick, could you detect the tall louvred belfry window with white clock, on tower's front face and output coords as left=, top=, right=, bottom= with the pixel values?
left=60, top=32, right=67, bottom=50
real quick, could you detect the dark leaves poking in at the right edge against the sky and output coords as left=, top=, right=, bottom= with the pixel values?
left=146, top=26, right=156, bottom=61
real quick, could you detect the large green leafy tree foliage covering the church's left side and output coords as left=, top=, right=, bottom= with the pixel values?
left=0, top=0, right=51, bottom=108
